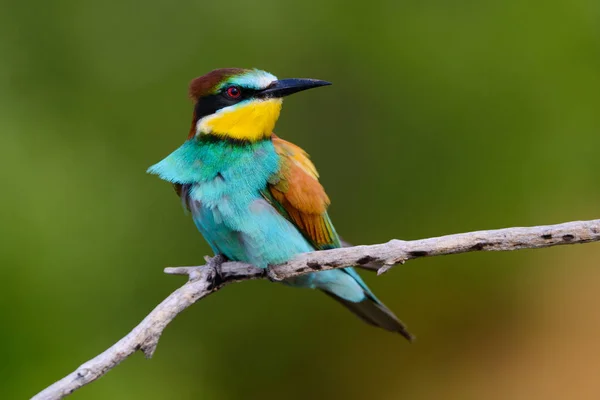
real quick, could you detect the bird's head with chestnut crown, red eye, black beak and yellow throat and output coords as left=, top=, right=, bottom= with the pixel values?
left=189, top=68, right=330, bottom=142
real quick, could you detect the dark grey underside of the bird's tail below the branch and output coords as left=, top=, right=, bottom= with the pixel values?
left=323, top=290, right=414, bottom=341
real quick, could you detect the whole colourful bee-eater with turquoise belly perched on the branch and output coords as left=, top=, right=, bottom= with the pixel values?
left=148, top=68, right=412, bottom=340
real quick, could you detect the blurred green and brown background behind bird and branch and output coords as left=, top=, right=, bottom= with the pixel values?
left=0, top=0, right=600, bottom=400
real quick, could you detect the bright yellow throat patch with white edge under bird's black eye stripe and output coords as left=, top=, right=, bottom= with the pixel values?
left=196, top=98, right=282, bottom=141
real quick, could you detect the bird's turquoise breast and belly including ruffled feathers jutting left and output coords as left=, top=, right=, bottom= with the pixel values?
left=148, top=139, right=313, bottom=268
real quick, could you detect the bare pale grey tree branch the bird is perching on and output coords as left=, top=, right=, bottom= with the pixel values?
left=32, top=220, right=600, bottom=400
